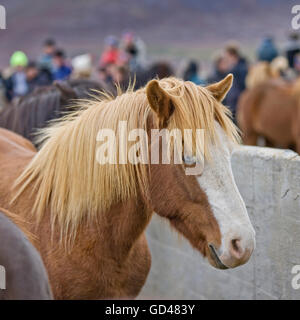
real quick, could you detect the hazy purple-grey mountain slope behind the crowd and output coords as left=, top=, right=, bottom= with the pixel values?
left=0, top=0, right=295, bottom=66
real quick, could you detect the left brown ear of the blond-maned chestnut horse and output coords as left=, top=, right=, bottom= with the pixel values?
left=146, top=80, right=174, bottom=128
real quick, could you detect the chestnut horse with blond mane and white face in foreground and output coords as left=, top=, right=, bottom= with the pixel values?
left=0, top=75, right=255, bottom=299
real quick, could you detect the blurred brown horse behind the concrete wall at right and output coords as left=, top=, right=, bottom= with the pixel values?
left=237, top=80, right=300, bottom=153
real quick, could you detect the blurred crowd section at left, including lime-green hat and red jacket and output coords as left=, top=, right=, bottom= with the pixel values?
left=0, top=32, right=145, bottom=102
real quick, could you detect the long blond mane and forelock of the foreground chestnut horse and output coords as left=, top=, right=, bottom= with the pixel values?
left=15, top=78, right=238, bottom=242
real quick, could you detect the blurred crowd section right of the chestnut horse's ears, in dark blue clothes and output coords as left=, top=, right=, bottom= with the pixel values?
left=190, top=32, right=300, bottom=119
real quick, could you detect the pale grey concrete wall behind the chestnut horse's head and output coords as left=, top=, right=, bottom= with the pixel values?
left=139, top=147, right=300, bottom=299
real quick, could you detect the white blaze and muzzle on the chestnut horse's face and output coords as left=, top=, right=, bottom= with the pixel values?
left=198, top=124, right=255, bottom=267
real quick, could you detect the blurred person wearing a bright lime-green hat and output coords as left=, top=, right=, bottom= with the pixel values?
left=6, top=51, right=28, bottom=101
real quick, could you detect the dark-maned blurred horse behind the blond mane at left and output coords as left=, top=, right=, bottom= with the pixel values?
left=0, top=80, right=105, bottom=146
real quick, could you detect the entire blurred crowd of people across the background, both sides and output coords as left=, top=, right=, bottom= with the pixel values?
left=0, top=32, right=300, bottom=121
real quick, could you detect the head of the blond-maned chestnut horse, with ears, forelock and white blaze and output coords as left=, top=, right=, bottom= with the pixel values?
left=146, top=75, right=255, bottom=269
